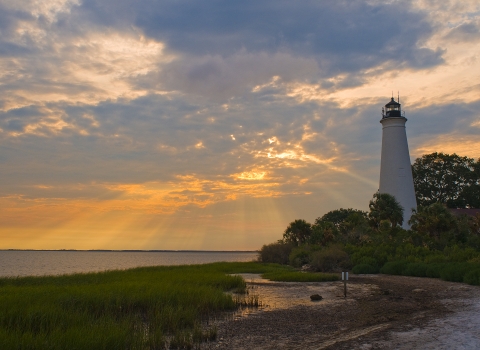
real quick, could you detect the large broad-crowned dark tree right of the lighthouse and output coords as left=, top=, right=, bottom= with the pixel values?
left=412, top=152, right=480, bottom=208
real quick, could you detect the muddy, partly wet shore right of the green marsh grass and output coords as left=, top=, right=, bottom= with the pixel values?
left=202, top=275, right=480, bottom=349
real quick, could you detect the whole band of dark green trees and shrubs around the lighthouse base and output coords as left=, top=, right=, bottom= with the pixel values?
left=260, top=153, right=480, bottom=284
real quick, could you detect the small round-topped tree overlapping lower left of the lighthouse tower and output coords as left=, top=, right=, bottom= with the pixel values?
left=368, top=192, right=403, bottom=229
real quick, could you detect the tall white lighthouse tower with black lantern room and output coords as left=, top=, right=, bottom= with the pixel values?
left=378, top=97, right=417, bottom=229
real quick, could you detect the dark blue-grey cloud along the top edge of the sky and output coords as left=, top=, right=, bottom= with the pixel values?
left=131, top=0, right=438, bottom=67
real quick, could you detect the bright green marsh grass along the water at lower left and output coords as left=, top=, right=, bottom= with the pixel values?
left=0, top=262, right=337, bottom=349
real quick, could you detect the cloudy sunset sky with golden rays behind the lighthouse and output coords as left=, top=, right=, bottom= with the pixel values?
left=0, top=0, right=480, bottom=250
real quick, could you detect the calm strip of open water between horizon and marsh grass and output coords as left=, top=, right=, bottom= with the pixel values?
left=0, top=251, right=257, bottom=276
